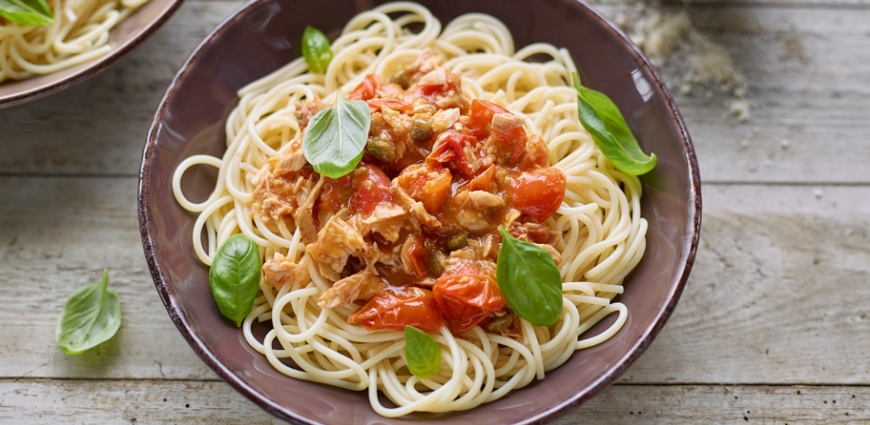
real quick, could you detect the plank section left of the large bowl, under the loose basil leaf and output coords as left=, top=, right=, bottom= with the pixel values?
left=0, top=178, right=214, bottom=378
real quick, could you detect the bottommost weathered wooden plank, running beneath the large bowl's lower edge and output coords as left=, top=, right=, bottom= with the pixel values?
left=0, top=379, right=870, bottom=425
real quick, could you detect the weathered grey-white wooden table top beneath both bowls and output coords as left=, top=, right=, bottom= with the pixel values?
left=0, top=0, right=870, bottom=424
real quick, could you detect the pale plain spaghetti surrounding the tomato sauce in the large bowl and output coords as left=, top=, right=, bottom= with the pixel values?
left=172, top=2, right=647, bottom=417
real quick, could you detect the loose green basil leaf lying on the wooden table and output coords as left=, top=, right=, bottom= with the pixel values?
left=55, top=269, right=121, bottom=355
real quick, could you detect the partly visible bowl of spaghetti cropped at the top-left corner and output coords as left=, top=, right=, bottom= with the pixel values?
left=0, top=0, right=181, bottom=108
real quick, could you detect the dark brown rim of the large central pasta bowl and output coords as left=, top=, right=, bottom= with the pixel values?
left=137, top=0, right=701, bottom=425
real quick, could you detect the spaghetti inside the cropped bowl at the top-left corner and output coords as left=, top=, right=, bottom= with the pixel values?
left=0, top=0, right=148, bottom=82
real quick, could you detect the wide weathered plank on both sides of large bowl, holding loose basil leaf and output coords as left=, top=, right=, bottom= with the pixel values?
left=0, top=177, right=870, bottom=384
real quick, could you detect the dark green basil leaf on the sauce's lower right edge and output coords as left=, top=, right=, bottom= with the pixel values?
left=495, top=226, right=562, bottom=326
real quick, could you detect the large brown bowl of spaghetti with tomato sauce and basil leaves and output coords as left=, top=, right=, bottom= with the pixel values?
left=139, top=0, right=701, bottom=424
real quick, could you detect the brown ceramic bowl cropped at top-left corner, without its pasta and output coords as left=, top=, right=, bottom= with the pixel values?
left=0, top=0, right=183, bottom=108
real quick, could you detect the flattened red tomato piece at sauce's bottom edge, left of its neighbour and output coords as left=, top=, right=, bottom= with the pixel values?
left=347, top=287, right=443, bottom=332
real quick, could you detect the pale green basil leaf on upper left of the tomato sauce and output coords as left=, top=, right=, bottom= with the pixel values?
left=302, top=90, right=372, bottom=179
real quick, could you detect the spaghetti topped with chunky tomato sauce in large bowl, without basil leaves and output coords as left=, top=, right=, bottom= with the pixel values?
left=173, top=3, right=647, bottom=417
